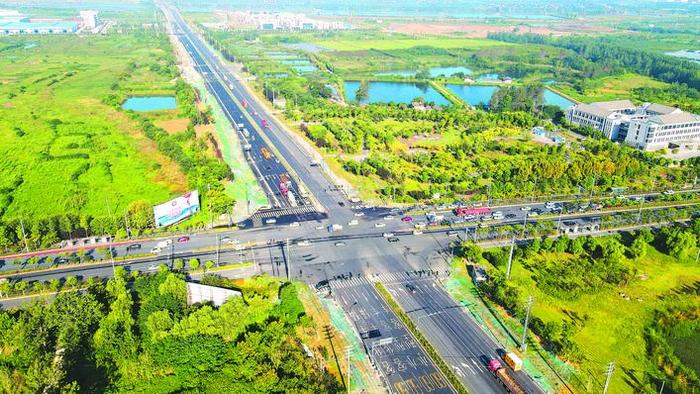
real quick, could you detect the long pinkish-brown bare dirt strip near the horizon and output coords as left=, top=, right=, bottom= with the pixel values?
left=384, top=23, right=611, bottom=38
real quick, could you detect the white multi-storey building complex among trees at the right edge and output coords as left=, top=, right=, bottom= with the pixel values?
left=566, top=100, right=700, bottom=150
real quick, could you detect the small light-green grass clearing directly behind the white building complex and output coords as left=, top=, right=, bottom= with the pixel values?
left=556, top=73, right=668, bottom=103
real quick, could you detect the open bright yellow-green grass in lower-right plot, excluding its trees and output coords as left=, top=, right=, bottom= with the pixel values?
left=476, top=247, right=700, bottom=393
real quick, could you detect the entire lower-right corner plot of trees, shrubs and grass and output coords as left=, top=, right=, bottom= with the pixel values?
left=460, top=220, right=700, bottom=393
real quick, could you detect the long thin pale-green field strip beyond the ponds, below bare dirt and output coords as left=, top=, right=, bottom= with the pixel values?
left=313, top=38, right=512, bottom=51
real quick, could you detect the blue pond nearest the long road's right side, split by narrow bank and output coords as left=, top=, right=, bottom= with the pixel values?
left=344, top=81, right=450, bottom=105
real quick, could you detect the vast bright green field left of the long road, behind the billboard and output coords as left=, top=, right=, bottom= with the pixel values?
left=0, top=34, right=187, bottom=219
